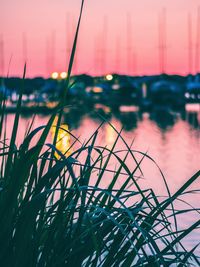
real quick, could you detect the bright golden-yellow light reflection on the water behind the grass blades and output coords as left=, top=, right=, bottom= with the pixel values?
left=51, top=118, right=71, bottom=158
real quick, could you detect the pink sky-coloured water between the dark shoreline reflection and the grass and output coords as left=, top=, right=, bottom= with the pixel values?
left=3, top=104, right=200, bottom=252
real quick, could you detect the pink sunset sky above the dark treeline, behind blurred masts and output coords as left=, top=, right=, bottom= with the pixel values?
left=0, top=0, right=200, bottom=77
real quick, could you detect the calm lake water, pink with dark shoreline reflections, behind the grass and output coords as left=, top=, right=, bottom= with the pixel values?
left=3, top=105, right=200, bottom=255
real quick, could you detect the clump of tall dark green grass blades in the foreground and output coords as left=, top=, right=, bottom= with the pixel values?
left=0, top=1, right=200, bottom=267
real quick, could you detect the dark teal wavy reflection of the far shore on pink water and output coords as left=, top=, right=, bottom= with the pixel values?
left=52, top=104, right=200, bottom=137
